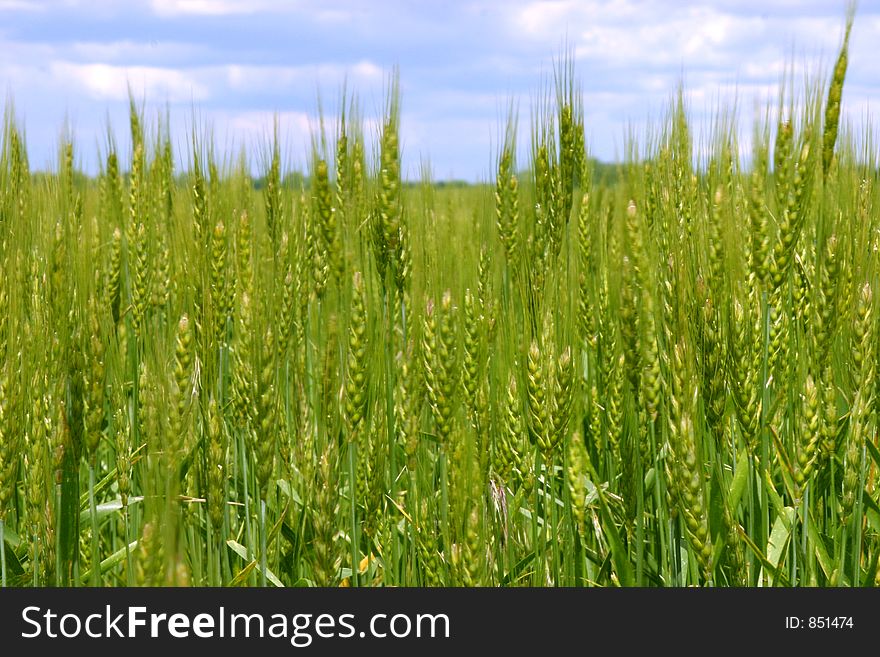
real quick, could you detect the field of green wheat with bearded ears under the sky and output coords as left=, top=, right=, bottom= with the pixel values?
left=0, top=11, right=880, bottom=586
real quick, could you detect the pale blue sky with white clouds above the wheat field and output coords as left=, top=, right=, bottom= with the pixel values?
left=0, top=0, right=880, bottom=180
